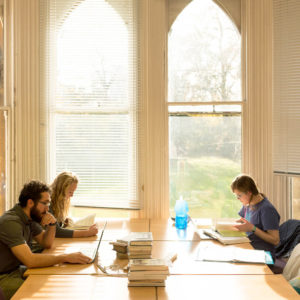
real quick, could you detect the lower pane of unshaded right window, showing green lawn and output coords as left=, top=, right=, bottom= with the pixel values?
left=169, top=116, right=241, bottom=218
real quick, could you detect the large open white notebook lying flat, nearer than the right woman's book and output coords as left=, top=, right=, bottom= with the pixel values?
left=196, top=245, right=273, bottom=264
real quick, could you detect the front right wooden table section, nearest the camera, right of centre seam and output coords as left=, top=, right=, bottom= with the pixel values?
left=157, top=275, right=300, bottom=300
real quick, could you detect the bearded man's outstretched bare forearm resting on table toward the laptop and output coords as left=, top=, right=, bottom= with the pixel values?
left=11, top=244, right=92, bottom=268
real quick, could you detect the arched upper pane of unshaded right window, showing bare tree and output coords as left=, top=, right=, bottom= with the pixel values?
left=168, top=0, right=241, bottom=102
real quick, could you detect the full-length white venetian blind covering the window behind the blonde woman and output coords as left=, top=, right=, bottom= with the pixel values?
left=40, top=0, right=139, bottom=209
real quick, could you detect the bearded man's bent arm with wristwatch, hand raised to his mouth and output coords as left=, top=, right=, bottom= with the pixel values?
left=34, top=212, right=56, bottom=249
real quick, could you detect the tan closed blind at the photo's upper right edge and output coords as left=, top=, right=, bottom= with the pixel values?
left=273, top=0, right=300, bottom=174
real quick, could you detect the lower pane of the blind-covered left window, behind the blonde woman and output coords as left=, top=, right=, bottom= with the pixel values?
left=56, top=114, right=135, bottom=208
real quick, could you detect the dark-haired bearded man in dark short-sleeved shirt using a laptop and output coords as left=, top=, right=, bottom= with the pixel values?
left=0, top=180, right=91, bottom=299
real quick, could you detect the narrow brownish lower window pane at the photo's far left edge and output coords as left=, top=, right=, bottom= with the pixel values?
left=0, top=111, right=7, bottom=214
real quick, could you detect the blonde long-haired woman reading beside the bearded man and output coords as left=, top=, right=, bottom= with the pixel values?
left=50, top=172, right=98, bottom=238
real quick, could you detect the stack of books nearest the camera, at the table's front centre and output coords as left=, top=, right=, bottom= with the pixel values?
left=128, top=259, right=169, bottom=286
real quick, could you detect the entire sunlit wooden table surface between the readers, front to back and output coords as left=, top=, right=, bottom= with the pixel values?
left=12, top=219, right=299, bottom=300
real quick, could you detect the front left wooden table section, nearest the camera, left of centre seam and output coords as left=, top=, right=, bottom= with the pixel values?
left=12, top=275, right=156, bottom=300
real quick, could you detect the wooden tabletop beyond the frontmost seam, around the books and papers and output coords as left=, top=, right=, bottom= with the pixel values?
left=25, top=219, right=272, bottom=276
